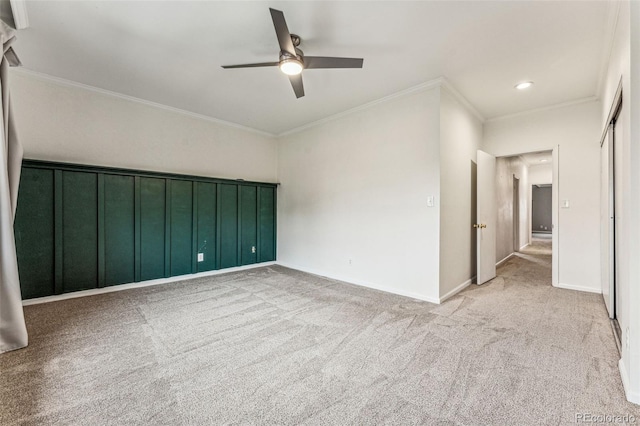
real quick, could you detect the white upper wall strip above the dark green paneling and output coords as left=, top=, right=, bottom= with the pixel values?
left=11, top=71, right=277, bottom=182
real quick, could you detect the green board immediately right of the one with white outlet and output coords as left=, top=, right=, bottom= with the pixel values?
left=218, top=184, right=238, bottom=268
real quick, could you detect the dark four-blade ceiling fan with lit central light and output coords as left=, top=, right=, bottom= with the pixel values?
left=222, top=8, right=364, bottom=98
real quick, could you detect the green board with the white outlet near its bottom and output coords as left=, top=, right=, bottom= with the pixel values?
left=195, top=182, right=217, bottom=272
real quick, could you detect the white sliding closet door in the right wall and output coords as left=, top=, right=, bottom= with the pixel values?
left=600, top=125, right=615, bottom=318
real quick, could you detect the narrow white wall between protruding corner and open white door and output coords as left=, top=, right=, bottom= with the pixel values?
left=440, top=88, right=482, bottom=298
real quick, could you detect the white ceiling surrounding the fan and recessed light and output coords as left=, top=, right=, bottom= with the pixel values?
left=15, top=0, right=613, bottom=134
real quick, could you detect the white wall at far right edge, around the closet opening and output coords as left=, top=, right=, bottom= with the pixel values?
left=599, top=2, right=640, bottom=404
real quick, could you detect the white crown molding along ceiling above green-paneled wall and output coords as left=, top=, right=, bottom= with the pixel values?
left=11, top=67, right=276, bottom=138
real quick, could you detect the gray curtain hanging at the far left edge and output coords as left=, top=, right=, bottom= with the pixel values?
left=0, top=21, right=28, bottom=353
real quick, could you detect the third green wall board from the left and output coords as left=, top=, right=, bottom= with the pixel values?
left=103, top=175, right=135, bottom=285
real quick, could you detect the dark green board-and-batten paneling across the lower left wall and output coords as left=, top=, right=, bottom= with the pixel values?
left=15, top=161, right=276, bottom=299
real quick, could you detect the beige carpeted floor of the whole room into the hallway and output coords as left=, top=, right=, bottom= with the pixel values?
left=0, top=241, right=640, bottom=425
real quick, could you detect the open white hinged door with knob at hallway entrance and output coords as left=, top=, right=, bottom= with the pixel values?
left=474, top=150, right=498, bottom=284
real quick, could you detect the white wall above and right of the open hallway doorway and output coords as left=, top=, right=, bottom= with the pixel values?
left=483, top=101, right=601, bottom=291
